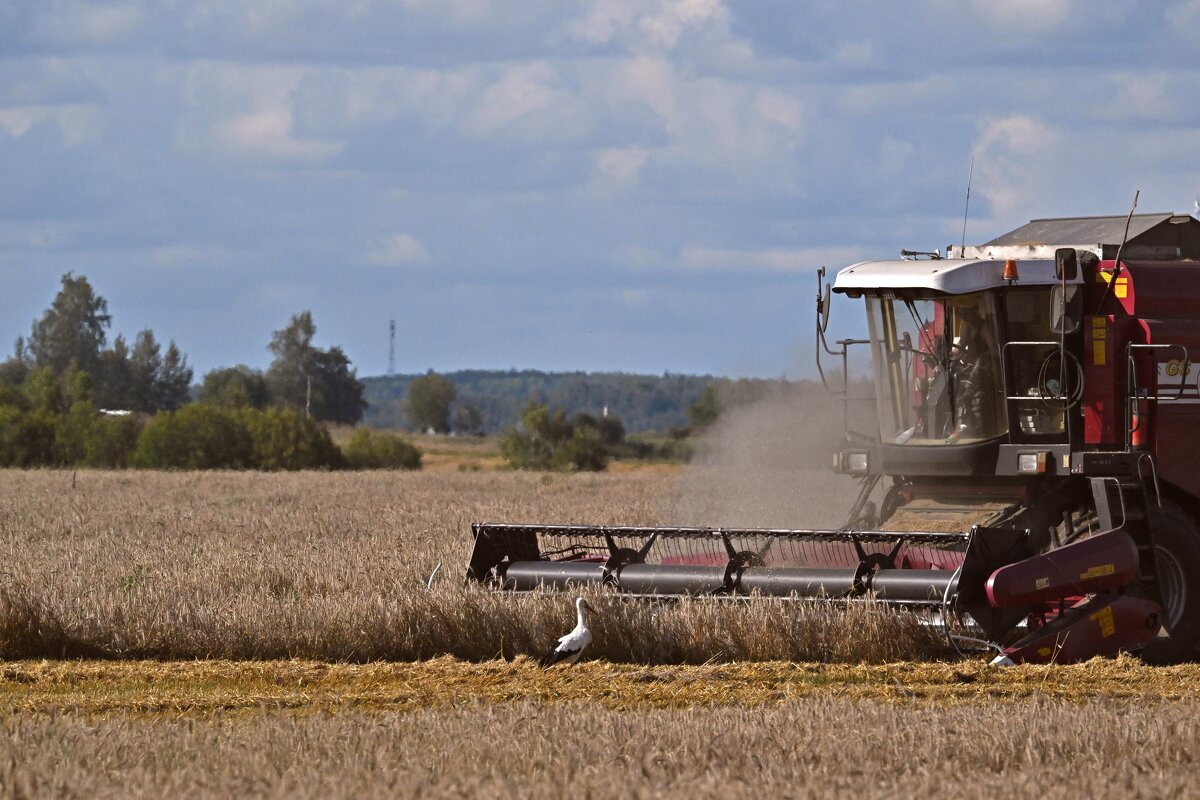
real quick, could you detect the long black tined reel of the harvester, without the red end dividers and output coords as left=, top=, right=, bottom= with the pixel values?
left=468, top=523, right=970, bottom=604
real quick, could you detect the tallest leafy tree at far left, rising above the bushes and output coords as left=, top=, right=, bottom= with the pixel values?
left=28, top=272, right=112, bottom=374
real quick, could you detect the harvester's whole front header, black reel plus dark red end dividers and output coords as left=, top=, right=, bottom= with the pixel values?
left=467, top=523, right=1160, bottom=661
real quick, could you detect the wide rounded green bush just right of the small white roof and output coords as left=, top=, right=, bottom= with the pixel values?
left=130, top=404, right=253, bottom=469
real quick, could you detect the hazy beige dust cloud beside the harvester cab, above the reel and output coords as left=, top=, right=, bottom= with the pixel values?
left=671, top=387, right=859, bottom=528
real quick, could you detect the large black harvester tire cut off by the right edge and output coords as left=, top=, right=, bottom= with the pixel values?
left=1141, top=501, right=1200, bottom=664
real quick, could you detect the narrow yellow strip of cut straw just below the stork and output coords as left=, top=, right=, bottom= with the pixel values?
left=0, top=657, right=1200, bottom=716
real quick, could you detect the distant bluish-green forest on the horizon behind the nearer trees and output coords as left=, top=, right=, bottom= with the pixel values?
left=361, top=369, right=820, bottom=433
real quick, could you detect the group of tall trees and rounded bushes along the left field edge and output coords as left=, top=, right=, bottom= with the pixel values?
left=0, top=272, right=420, bottom=469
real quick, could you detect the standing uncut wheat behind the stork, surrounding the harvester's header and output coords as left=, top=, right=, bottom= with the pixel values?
left=0, top=471, right=943, bottom=663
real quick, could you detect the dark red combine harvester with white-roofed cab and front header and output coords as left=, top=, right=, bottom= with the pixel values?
left=467, top=213, right=1200, bottom=663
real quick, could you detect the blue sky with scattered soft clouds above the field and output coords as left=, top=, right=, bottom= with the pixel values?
left=0, top=0, right=1200, bottom=378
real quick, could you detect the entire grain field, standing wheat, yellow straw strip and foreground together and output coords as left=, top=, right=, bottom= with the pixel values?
left=0, top=470, right=1200, bottom=796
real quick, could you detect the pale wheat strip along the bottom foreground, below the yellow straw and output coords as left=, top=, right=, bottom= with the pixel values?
left=0, top=698, right=1200, bottom=800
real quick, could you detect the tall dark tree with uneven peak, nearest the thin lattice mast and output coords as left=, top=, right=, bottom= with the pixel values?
left=266, top=311, right=366, bottom=425
